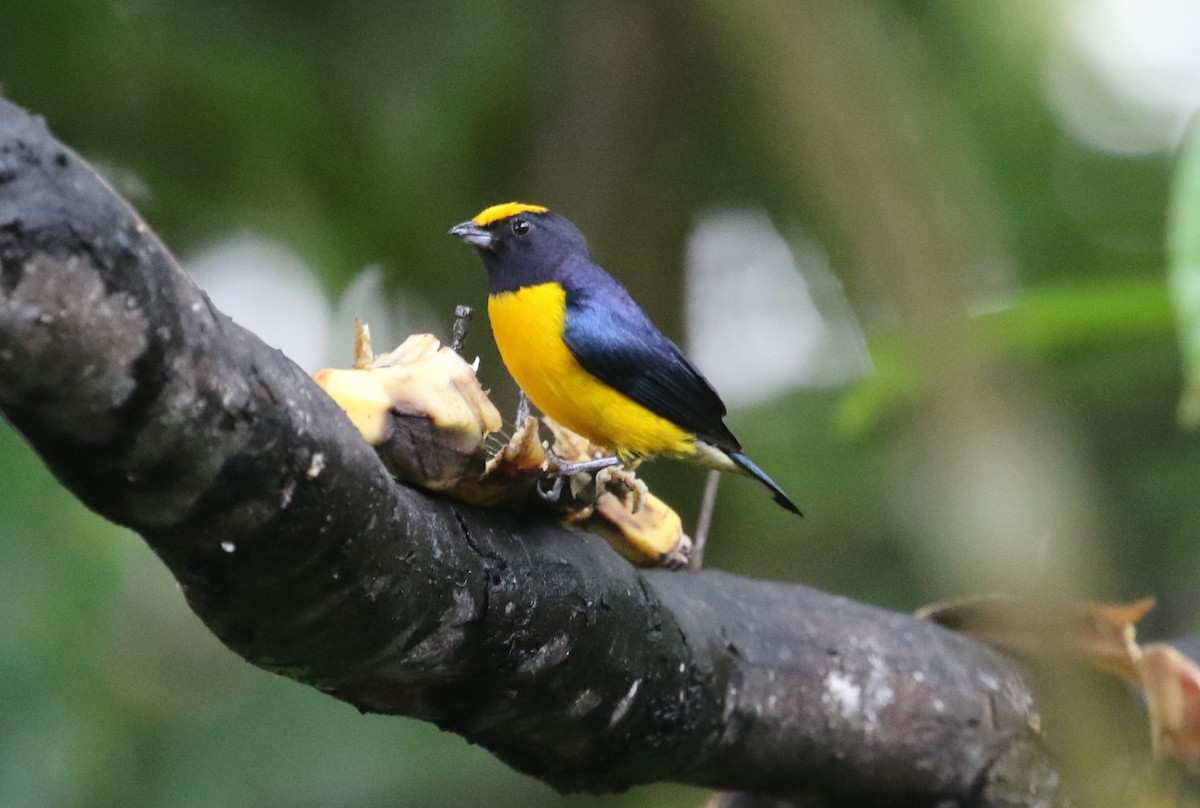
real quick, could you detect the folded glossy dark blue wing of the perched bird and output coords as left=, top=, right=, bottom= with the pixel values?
left=563, top=275, right=742, bottom=453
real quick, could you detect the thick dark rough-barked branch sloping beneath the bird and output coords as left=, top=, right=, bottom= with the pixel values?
left=0, top=100, right=1061, bottom=806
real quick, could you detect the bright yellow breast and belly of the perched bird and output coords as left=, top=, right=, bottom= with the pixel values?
left=487, top=283, right=696, bottom=457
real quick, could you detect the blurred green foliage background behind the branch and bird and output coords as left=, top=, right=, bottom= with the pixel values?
left=0, top=0, right=1200, bottom=808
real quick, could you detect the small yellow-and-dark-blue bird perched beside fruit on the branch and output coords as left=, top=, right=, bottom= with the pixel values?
left=450, top=202, right=802, bottom=515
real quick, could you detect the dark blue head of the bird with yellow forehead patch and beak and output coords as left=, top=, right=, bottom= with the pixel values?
left=450, top=202, right=588, bottom=294
